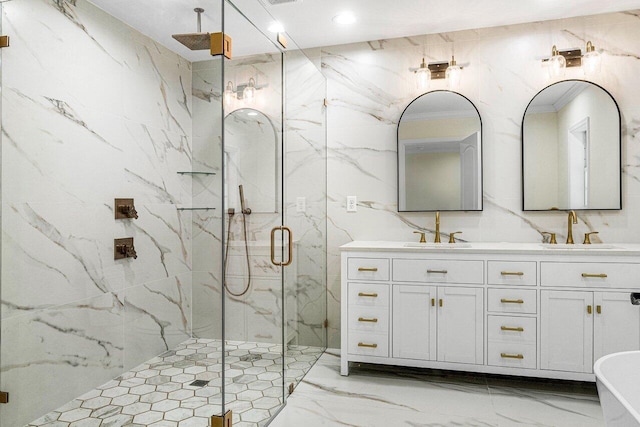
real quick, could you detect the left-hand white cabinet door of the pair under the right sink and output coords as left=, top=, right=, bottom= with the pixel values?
left=540, top=291, right=594, bottom=373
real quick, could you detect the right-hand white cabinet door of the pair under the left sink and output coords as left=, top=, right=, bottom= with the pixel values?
left=437, top=286, right=484, bottom=364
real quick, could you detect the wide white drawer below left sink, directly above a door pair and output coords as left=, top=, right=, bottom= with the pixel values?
left=393, top=259, right=484, bottom=285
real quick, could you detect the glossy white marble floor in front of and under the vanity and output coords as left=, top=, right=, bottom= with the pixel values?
left=270, top=349, right=604, bottom=427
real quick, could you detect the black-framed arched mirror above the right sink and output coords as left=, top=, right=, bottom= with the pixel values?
left=522, top=80, right=622, bottom=211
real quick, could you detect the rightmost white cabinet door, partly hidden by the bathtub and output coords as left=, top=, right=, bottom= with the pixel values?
left=593, top=292, right=640, bottom=362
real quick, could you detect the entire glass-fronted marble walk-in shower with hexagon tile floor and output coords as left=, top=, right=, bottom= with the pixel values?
left=0, top=0, right=326, bottom=426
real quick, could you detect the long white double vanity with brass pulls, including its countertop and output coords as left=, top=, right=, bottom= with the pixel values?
left=341, top=242, right=640, bottom=381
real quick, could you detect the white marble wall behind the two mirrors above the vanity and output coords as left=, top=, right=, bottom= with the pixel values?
left=318, top=11, right=640, bottom=347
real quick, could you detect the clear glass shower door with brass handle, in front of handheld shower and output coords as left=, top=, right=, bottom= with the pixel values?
left=222, top=2, right=288, bottom=425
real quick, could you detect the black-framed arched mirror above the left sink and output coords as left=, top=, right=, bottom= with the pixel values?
left=398, top=90, right=482, bottom=212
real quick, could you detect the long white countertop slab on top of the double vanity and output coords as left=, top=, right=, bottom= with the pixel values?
left=340, top=240, right=640, bottom=256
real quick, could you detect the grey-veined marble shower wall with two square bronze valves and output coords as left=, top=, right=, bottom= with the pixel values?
left=0, top=0, right=192, bottom=426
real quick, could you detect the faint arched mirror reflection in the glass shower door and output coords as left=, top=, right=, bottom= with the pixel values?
left=224, top=108, right=278, bottom=213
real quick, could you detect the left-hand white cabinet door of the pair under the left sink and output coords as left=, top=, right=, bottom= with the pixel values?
left=393, top=285, right=436, bottom=360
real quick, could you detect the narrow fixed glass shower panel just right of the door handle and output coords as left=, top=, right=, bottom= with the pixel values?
left=284, top=50, right=327, bottom=390
